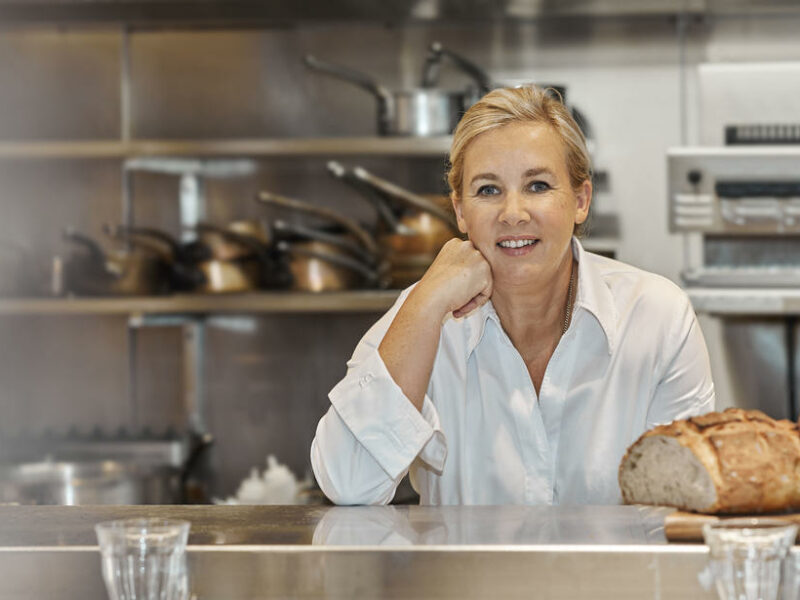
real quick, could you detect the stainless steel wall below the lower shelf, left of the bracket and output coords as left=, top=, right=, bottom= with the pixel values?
left=0, top=316, right=186, bottom=438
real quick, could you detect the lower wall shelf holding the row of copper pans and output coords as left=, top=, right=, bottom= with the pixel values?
left=0, top=290, right=400, bottom=316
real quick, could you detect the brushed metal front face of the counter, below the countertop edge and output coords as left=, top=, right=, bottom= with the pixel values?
left=0, top=546, right=716, bottom=600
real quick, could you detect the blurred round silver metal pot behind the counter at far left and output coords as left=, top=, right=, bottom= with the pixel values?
left=0, top=460, right=182, bottom=505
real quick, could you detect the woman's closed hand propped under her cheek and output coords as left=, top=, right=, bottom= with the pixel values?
left=415, top=238, right=492, bottom=317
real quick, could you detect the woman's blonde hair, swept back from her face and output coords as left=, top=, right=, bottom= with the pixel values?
left=447, top=84, right=592, bottom=232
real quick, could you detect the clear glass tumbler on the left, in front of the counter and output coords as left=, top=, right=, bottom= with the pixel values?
left=95, top=519, right=189, bottom=600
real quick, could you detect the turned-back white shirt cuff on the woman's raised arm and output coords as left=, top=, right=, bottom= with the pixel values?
left=329, top=348, right=447, bottom=480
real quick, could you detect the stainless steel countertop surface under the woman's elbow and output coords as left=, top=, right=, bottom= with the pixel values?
left=0, top=505, right=670, bottom=547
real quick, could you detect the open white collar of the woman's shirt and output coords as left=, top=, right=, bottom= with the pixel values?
left=465, top=237, right=617, bottom=357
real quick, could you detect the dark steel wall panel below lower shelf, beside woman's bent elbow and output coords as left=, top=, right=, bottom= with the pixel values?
left=200, top=315, right=376, bottom=497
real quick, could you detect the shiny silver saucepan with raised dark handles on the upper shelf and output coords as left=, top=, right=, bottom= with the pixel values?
left=303, top=42, right=491, bottom=137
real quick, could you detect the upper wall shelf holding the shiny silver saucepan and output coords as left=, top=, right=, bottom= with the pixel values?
left=0, top=136, right=451, bottom=160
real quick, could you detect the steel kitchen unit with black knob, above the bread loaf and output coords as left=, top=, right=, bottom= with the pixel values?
left=668, top=145, right=800, bottom=419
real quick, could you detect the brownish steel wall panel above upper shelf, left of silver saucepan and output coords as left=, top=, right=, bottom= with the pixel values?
left=131, top=25, right=400, bottom=138
